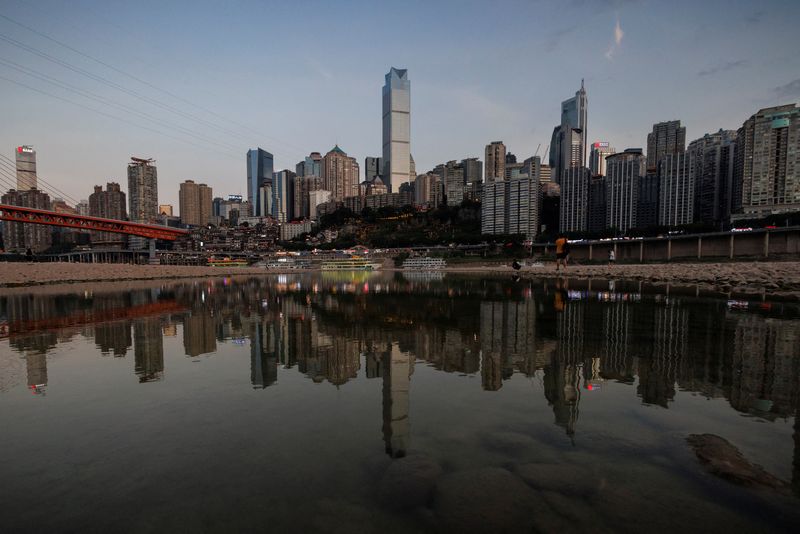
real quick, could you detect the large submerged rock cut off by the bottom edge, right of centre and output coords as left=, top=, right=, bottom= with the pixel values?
left=434, top=467, right=549, bottom=532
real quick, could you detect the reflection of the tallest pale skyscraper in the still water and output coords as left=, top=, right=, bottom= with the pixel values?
left=383, top=344, right=414, bottom=458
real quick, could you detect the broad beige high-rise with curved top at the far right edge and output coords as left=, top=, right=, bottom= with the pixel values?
left=734, top=104, right=800, bottom=218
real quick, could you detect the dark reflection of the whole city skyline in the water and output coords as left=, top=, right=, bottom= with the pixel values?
left=0, top=273, right=800, bottom=464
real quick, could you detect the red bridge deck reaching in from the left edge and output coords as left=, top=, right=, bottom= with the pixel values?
left=0, top=204, right=189, bottom=241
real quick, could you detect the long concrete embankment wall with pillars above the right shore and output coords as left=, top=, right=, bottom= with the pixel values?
left=533, top=227, right=800, bottom=263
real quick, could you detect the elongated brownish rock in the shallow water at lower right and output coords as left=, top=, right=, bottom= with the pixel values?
left=686, top=434, right=787, bottom=490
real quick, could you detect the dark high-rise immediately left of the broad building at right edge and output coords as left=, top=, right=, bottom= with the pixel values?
left=686, top=130, right=736, bottom=226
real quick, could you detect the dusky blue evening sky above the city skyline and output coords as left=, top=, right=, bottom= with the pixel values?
left=0, top=0, right=800, bottom=210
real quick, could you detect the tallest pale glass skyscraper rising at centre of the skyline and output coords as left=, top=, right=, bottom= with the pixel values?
left=382, top=67, right=411, bottom=191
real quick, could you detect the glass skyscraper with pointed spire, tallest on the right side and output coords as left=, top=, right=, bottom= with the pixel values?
left=550, top=80, right=588, bottom=181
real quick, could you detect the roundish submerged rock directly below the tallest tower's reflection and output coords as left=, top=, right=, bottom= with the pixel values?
left=378, top=455, right=442, bottom=510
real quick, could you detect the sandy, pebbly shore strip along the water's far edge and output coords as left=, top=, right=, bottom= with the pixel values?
left=0, top=262, right=800, bottom=299
